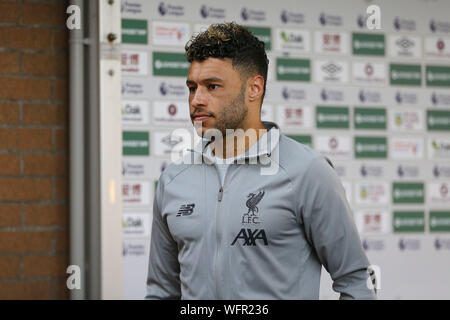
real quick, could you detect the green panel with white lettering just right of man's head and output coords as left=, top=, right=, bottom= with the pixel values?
left=277, top=58, right=311, bottom=81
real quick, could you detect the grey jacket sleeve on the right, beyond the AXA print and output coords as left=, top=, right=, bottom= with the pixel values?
left=300, top=157, right=376, bottom=299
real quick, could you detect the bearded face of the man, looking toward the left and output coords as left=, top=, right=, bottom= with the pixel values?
left=186, top=58, right=248, bottom=135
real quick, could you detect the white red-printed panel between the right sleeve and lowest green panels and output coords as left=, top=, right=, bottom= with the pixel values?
left=355, top=209, right=391, bottom=234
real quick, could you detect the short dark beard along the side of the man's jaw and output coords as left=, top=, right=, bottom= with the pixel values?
left=216, top=87, right=248, bottom=137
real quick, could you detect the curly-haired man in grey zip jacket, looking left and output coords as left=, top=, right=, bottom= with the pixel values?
left=146, top=23, right=375, bottom=299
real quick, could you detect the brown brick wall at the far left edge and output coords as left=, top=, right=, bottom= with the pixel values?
left=0, top=0, right=69, bottom=299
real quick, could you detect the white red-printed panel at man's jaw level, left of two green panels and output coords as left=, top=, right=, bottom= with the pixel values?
left=276, top=105, right=313, bottom=128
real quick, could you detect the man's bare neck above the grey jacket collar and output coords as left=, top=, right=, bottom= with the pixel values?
left=213, top=120, right=267, bottom=158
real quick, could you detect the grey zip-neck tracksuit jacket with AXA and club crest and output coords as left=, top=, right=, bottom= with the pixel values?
left=146, top=122, right=376, bottom=300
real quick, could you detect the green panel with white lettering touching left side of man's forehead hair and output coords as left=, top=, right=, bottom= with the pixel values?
left=153, top=52, right=190, bottom=77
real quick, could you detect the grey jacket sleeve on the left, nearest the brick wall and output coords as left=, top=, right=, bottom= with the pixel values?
left=145, top=177, right=181, bottom=300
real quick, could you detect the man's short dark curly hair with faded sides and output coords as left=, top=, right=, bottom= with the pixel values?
left=185, top=22, right=269, bottom=104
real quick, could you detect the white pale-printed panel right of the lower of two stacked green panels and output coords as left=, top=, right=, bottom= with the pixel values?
left=390, top=137, right=424, bottom=160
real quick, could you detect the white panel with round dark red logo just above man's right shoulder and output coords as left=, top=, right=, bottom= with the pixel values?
left=314, top=135, right=352, bottom=160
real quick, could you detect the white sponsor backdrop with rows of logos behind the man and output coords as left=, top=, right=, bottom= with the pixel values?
left=118, top=0, right=450, bottom=299
